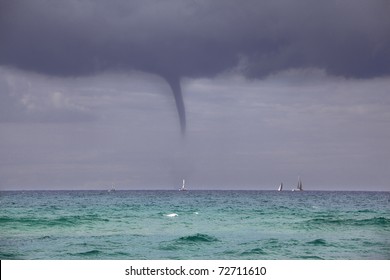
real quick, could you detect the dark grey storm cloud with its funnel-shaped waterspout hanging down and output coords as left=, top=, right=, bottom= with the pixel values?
left=0, top=0, right=390, bottom=130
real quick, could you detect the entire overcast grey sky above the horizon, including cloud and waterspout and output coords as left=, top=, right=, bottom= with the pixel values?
left=0, top=0, right=390, bottom=191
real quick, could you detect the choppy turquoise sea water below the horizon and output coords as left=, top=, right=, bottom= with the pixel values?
left=0, top=191, right=390, bottom=260
